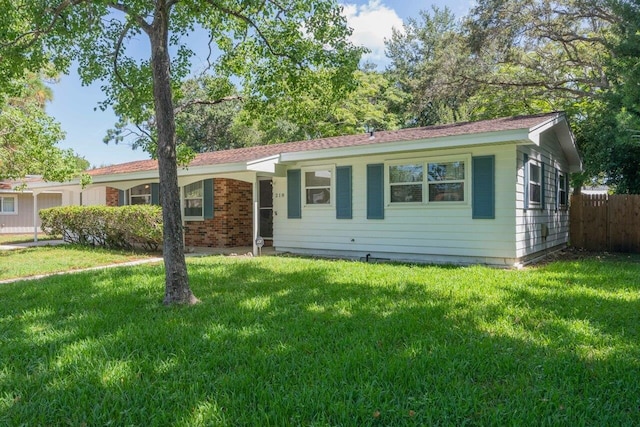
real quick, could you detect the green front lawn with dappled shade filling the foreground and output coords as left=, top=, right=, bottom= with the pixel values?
left=0, top=257, right=640, bottom=426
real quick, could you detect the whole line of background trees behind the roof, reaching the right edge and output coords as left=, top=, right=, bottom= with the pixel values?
left=162, top=0, right=640, bottom=193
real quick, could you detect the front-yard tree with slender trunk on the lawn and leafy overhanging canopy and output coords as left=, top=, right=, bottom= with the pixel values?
left=0, top=0, right=361, bottom=304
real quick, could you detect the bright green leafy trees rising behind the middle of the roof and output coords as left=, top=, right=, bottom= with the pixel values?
left=168, top=65, right=407, bottom=153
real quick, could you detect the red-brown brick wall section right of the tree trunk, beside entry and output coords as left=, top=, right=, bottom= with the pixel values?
left=185, top=178, right=253, bottom=248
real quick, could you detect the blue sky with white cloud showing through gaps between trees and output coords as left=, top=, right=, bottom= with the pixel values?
left=47, top=0, right=472, bottom=166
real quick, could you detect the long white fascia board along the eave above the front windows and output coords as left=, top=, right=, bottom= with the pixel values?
left=280, top=129, right=531, bottom=162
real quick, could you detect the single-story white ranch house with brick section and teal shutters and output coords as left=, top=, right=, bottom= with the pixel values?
left=27, top=113, right=582, bottom=266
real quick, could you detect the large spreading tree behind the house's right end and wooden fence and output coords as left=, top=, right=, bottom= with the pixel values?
left=387, top=0, right=640, bottom=193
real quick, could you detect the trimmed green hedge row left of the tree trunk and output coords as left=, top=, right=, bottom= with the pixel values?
left=40, top=205, right=162, bottom=250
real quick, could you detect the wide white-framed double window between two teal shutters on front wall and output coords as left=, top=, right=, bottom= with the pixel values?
left=387, top=156, right=469, bottom=205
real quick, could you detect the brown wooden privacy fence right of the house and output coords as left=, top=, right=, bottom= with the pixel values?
left=570, top=194, right=640, bottom=253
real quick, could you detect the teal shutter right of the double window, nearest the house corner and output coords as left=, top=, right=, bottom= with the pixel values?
left=471, top=156, right=496, bottom=219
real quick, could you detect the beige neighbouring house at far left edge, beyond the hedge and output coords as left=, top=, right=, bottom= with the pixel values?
left=0, top=176, right=65, bottom=234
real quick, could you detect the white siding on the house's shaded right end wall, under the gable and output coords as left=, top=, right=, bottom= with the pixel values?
left=516, top=132, right=569, bottom=260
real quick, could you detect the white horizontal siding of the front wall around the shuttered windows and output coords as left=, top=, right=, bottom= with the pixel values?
left=274, top=145, right=516, bottom=265
